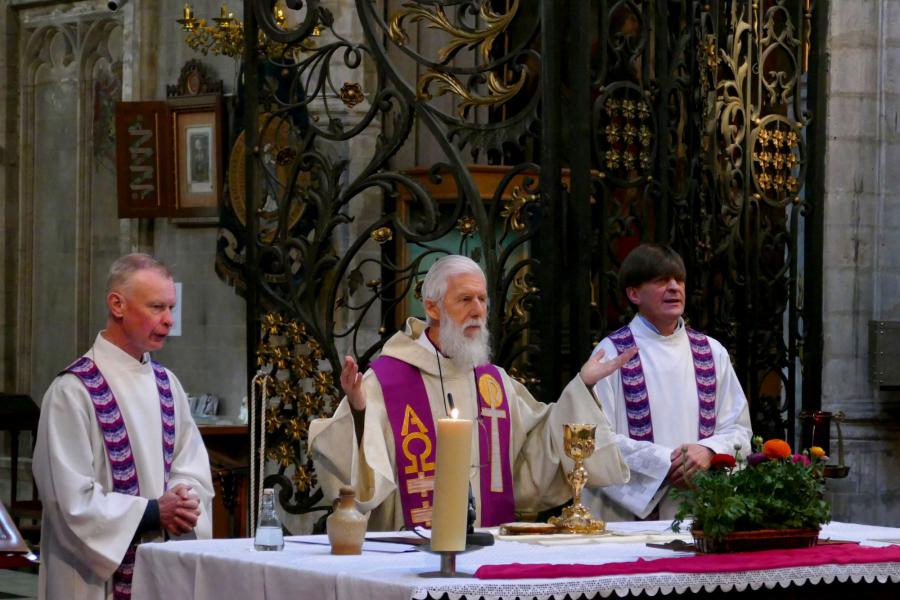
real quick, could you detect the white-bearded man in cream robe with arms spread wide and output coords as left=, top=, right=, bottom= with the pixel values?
left=309, top=255, right=630, bottom=530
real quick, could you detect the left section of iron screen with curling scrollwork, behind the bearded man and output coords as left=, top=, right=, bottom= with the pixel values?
left=237, top=0, right=542, bottom=512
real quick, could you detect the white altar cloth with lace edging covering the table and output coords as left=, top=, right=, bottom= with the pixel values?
left=132, top=521, right=900, bottom=600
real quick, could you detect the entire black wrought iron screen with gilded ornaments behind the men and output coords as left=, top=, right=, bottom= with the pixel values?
left=235, top=0, right=824, bottom=511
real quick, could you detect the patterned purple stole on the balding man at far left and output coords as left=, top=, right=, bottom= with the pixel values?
left=64, top=356, right=175, bottom=600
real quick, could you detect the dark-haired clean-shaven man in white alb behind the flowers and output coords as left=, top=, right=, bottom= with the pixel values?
left=584, top=244, right=751, bottom=521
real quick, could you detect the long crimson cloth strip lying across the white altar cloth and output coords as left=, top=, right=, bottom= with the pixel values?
left=475, top=544, right=900, bottom=579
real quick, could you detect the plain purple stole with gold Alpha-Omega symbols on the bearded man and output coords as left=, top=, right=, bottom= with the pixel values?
left=371, top=356, right=515, bottom=529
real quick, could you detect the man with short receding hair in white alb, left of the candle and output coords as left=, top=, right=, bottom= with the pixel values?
left=32, top=254, right=213, bottom=600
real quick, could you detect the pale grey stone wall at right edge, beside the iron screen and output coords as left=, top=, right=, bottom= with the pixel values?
left=824, top=0, right=900, bottom=526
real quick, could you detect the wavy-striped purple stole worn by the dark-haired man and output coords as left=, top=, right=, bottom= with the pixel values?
left=609, top=326, right=716, bottom=442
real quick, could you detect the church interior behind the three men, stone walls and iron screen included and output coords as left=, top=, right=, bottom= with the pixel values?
left=0, top=0, right=900, bottom=552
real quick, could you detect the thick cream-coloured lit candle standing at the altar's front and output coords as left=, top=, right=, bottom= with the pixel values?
left=431, top=408, right=472, bottom=552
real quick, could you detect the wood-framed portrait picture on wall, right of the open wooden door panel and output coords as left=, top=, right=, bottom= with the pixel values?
left=169, top=94, right=224, bottom=217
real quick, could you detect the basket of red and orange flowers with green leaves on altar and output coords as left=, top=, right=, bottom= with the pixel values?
left=672, top=436, right=831, bottom=541
